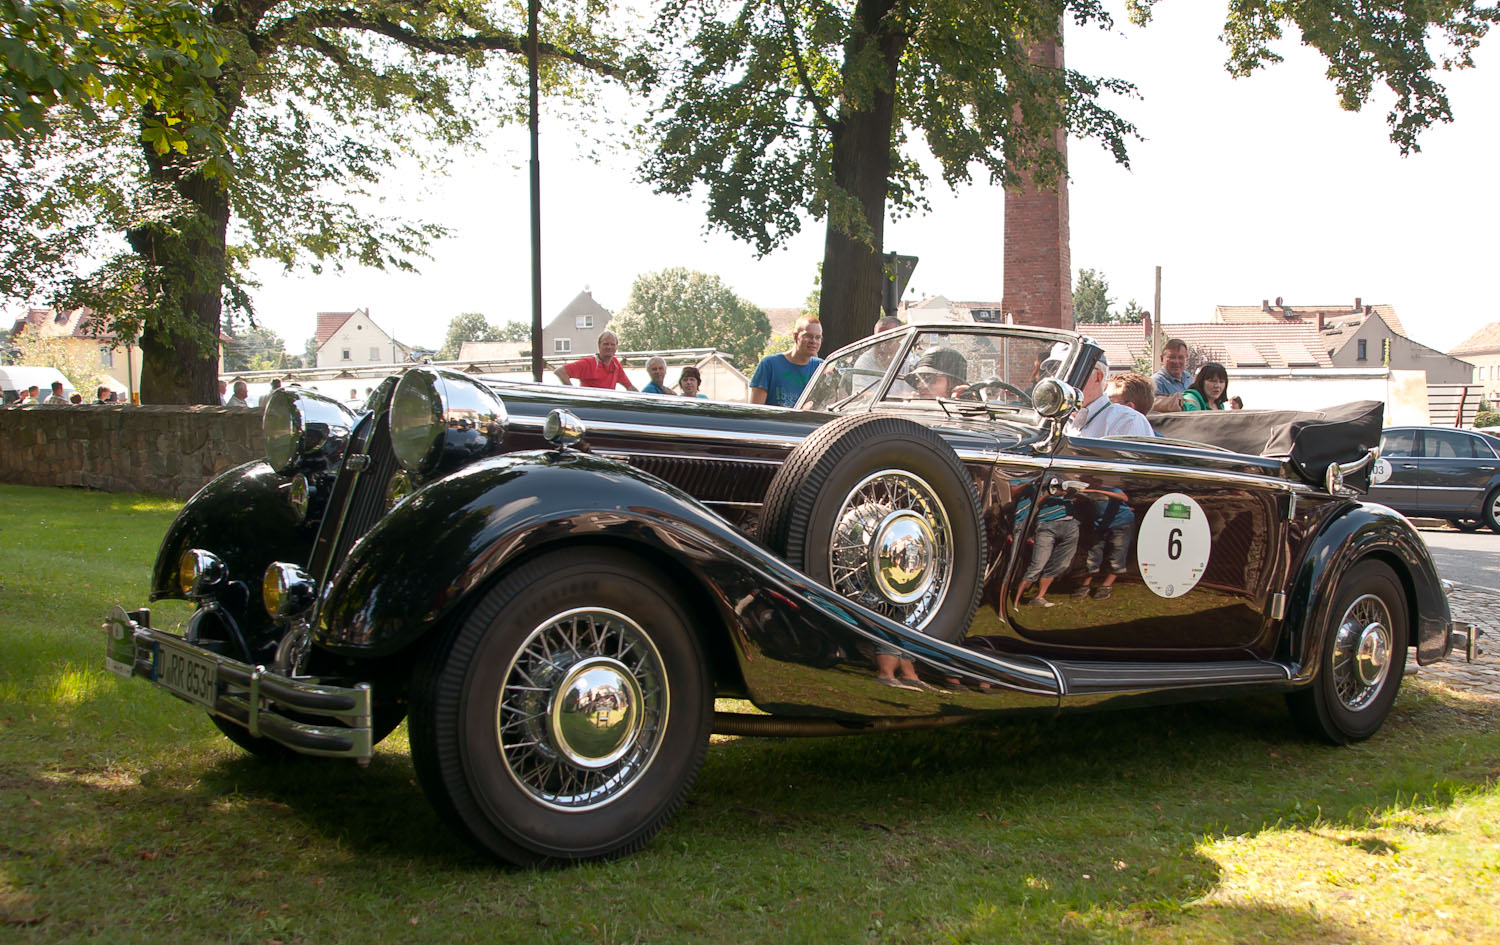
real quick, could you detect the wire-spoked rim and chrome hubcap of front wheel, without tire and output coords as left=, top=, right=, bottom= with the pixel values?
left=495, top=608, right=669, bottom=810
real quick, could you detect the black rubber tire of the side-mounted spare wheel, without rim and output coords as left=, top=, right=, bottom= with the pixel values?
left=761, top=414, right=987, bottom=639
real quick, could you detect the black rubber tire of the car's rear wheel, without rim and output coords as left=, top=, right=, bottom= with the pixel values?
left=1287, top=560, right=1410, bottom=746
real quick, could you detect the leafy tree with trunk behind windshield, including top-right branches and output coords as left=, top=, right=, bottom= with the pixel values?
left=644, top=0, right=1500, bottom=355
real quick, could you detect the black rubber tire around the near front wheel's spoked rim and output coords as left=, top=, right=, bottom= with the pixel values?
left=408, top=548, right=714, bottom=867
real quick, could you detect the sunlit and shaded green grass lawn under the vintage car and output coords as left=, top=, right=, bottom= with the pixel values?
left=0, top=486, right=1500, bottom=945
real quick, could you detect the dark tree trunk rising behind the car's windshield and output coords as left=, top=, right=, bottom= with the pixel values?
left=818, top=0, right=908, bottom=354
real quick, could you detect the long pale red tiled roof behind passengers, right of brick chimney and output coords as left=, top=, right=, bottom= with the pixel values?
left=1077, top=321, right=1334, bottom=371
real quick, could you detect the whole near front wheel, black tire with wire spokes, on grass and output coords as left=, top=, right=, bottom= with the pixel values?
left=410, top=549, right=713, bottom=866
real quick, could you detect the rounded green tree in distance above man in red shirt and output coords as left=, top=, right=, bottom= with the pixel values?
left=609, top=267, right=771, bottom=369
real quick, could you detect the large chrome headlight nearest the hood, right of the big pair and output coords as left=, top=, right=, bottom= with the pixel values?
left=390, top=368, right=507, bottom=477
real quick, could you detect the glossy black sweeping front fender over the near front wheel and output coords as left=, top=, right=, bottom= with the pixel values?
left=315, top=453, right=1058, bottom=708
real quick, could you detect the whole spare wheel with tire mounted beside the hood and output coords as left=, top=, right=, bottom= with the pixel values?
left=761, top=414, right=986, bottom=641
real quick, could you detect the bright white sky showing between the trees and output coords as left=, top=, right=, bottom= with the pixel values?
left=243, top=0, right=1500, bottom=354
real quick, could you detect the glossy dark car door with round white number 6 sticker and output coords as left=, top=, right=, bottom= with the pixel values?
left=1005, top=438, right=1289, bottom=659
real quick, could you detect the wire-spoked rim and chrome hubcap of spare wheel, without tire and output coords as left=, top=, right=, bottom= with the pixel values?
left=828, top=470, right=953, bottom=629
